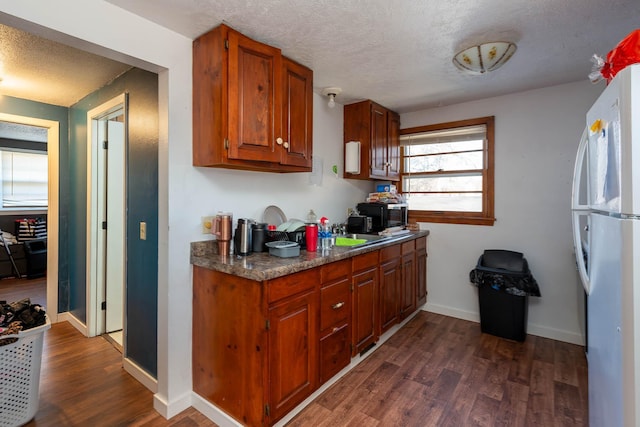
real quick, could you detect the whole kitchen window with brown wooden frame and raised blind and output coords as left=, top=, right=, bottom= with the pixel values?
left=400, top=117, right=495, bottom=225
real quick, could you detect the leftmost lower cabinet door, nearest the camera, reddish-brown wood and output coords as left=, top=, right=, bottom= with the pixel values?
left=269, top=290, right=319, bottom=422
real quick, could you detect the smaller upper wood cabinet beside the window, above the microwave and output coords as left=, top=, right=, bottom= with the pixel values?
left=344, top=100, right=400, bottom=181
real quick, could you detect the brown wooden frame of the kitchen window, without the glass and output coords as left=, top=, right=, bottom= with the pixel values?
left=399, top=116, right=496, bottom=226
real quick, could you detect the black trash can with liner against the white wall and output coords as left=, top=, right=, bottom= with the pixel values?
left=469, top=249, right=540, bottom=342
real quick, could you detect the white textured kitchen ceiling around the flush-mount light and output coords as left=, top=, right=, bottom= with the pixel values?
left=107, top=0, right=640, bottom=112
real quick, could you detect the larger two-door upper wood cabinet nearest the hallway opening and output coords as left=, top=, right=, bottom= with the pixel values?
left=193, top=25, right=313, bottom=172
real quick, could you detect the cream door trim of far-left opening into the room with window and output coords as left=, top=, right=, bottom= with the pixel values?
left=0, top=113, right=60, bottom=323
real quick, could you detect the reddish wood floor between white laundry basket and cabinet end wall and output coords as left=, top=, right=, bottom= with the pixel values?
left=21, top=322, right=215, bottom=427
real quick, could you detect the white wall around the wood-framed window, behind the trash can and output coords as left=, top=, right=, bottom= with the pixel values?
left=401, top=80, right=604, bottom=344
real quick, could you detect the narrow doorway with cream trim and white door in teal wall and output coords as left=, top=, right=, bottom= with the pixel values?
left=87, top=94, right=127, bottom=353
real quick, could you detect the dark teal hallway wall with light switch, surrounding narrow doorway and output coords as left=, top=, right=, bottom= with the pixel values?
left=68, top=69, right=158, bottom=377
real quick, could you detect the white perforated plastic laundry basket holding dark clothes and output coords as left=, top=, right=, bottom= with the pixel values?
left=0, top=317, right=51, bottom=427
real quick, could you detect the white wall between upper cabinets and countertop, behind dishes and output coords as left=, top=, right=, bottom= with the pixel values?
left=189, top=94, right=373, bottom=231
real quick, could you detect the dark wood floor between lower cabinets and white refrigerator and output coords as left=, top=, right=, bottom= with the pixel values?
left=288, top=312, right=588, bottom=427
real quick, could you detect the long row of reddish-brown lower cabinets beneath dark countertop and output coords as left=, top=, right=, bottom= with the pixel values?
left=192, top=237, right=427, bottom=426
